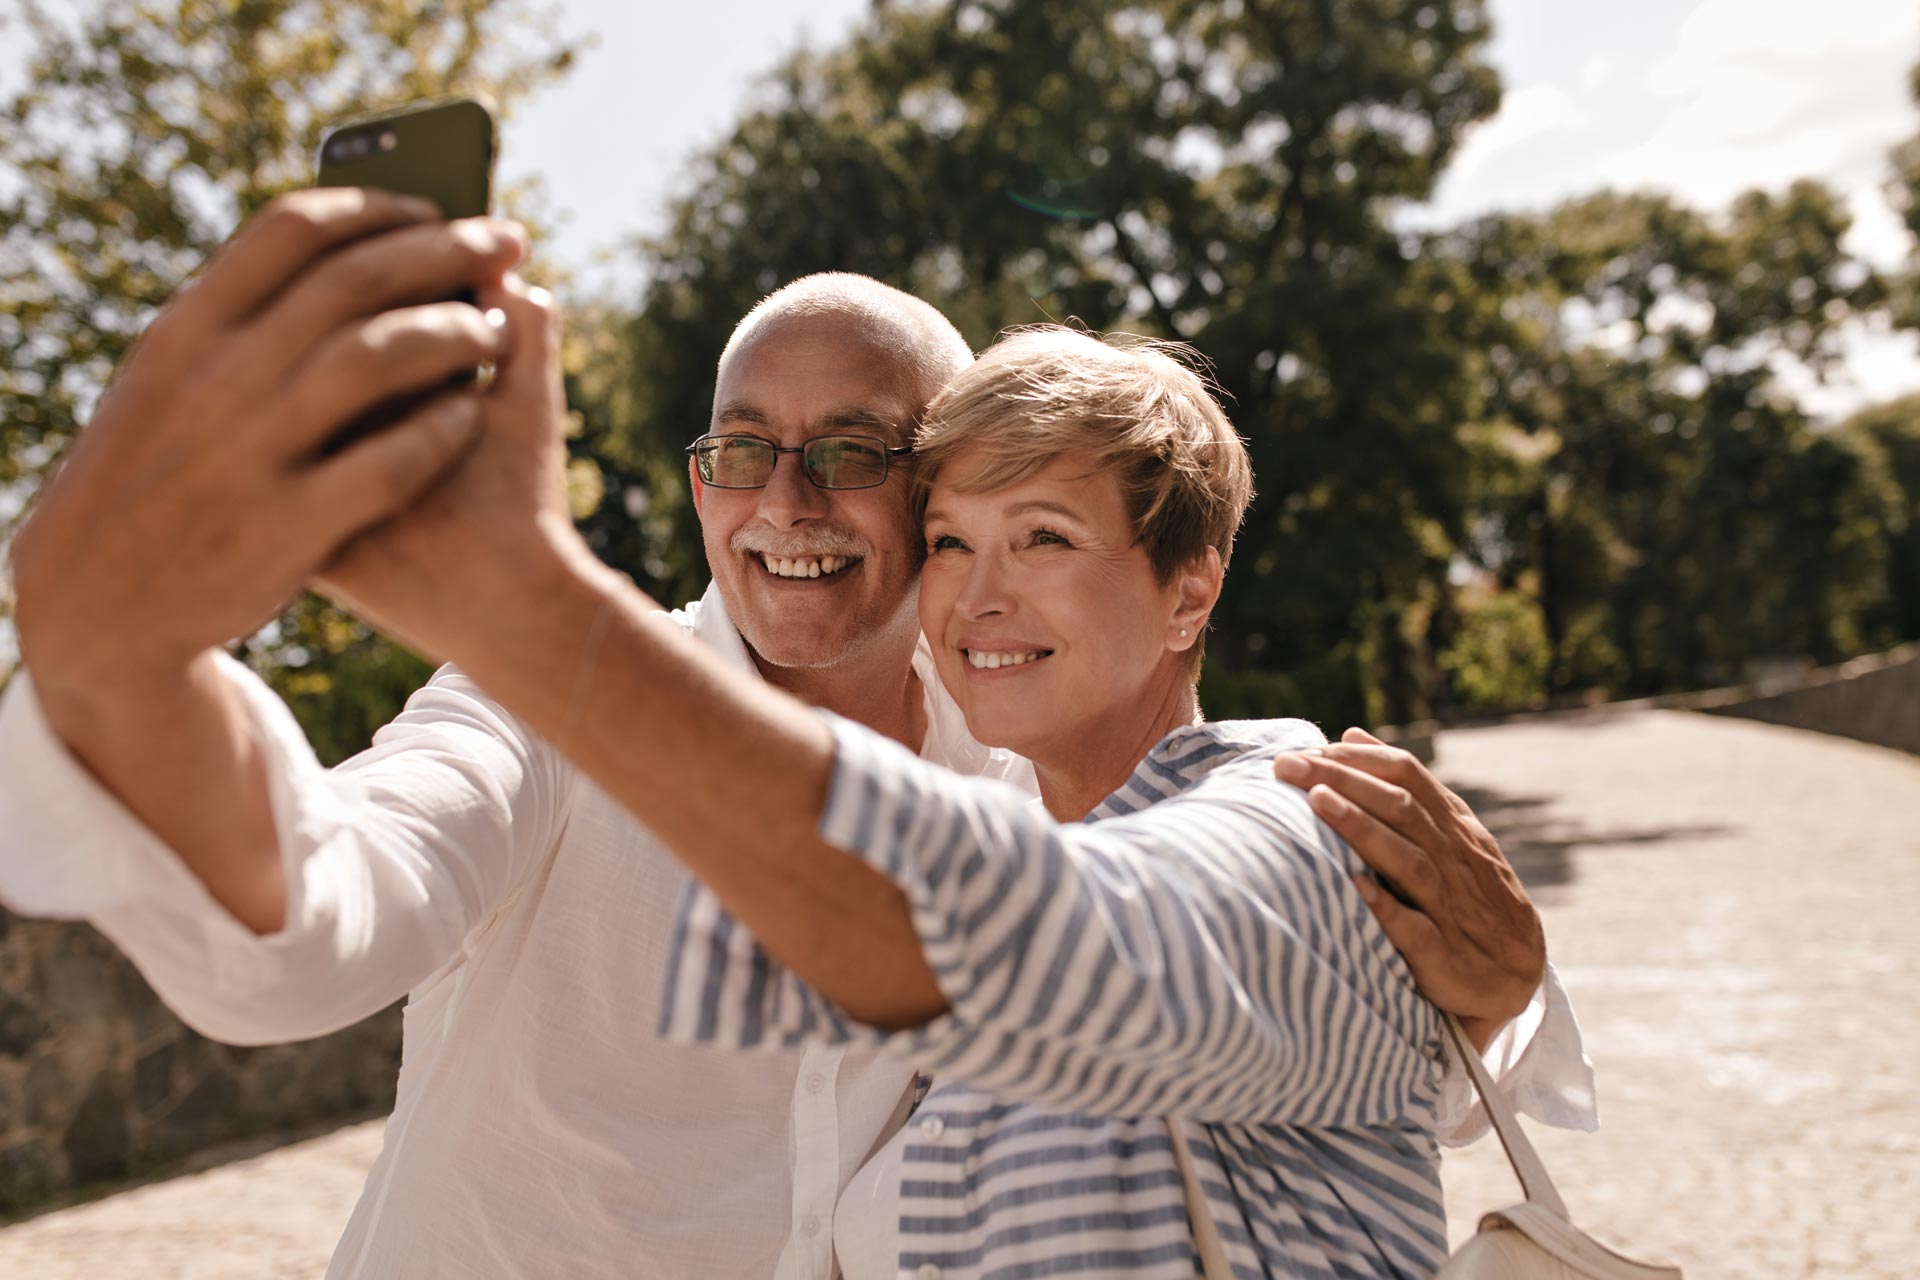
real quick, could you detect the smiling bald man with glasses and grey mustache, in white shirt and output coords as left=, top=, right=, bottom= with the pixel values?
left=0, top=192, right=1582, bottom=1278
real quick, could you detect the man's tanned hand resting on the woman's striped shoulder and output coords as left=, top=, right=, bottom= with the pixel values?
left=1273, top=729, right=1548, bottom=1048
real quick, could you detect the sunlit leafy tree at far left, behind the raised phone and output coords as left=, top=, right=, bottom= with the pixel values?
left=0, top=0, right=576, bottom=758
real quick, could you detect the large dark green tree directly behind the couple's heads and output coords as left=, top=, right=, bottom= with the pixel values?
left=609, top=0, right=1500, bottom=720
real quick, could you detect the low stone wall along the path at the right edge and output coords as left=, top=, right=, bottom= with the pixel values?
left=1682, top=645, right=1920, bottom=754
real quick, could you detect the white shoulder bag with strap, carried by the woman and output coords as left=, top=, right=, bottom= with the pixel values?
left=1167, top=1015, right=1680, bottom=1280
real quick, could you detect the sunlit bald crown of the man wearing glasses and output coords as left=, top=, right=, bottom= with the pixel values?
left=714, top=271, right=973, bottom=418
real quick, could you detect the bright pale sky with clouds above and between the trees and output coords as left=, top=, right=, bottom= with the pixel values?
left=501, top=0, right=1920, bottom=415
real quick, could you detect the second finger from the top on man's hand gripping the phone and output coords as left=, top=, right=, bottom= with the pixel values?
left=253, top=219, right=526, bottom=378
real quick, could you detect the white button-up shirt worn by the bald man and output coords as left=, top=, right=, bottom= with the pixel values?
left=0, top=591, right=1033, bottom=1280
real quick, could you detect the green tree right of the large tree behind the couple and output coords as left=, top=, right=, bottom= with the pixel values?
left=1428, top=182, right=1885, bottom=691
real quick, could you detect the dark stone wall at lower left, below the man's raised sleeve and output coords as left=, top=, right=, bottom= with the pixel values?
left=0, top=912, right=399, bottom=1217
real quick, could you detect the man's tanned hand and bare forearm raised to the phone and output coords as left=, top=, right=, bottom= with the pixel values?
left=12, top=190, right=526, bottom=933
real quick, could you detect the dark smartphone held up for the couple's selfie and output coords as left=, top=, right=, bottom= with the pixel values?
left=315, top=100, right=493, bottom=453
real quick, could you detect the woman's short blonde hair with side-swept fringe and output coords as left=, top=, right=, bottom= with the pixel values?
left=914, top=324, right=1254, bottom=666
